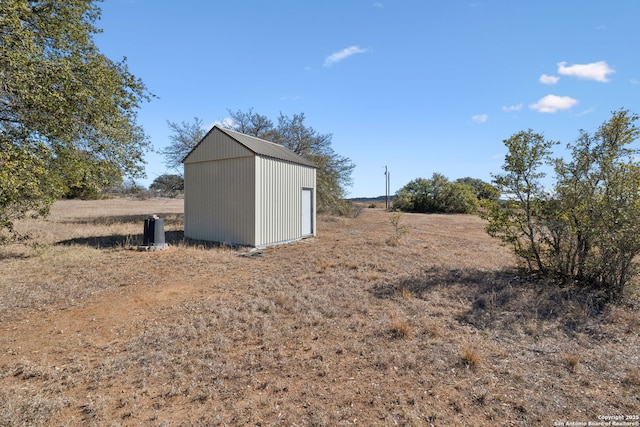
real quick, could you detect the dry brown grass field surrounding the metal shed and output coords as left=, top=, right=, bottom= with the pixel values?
left=0, top=199, right=640, bottom=426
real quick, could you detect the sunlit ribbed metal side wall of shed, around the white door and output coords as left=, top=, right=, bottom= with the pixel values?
left=255, top=156, right=316, bottom=246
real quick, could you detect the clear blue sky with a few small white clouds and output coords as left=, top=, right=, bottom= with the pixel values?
left=96, top=0, right=640, bottom=197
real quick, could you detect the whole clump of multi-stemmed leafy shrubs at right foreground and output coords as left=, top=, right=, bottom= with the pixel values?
left=486, top=110, right=640, bottom=300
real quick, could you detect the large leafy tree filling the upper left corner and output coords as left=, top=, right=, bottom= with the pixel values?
left=0, top=0, right=151, bottom=241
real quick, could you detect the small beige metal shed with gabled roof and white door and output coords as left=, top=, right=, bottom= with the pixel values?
left=182, top=126, right=316, bottom=247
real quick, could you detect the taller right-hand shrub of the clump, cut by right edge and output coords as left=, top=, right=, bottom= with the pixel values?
left=552, top=110, right=640, bottom=298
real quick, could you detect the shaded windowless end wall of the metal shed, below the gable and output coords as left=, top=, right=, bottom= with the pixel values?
left=184, top=156, right=256, bottom=246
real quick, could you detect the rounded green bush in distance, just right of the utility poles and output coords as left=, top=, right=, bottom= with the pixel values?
left=392, top=173, right=478, bottom=213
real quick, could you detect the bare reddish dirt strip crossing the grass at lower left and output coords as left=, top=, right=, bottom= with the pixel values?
left=0, top=256, right=255, bottom=372
